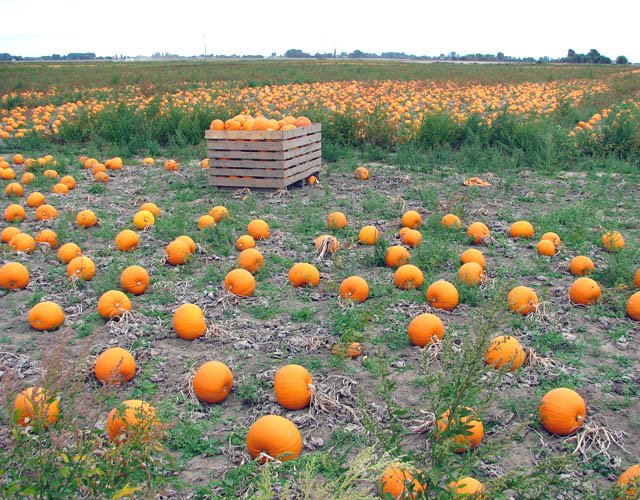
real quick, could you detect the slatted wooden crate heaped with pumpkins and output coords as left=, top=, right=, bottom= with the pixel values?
left=205, top=123, right=322, bottom=189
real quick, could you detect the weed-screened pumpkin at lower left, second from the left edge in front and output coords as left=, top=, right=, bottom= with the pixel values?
left=107, top=399, right=159, bottom=441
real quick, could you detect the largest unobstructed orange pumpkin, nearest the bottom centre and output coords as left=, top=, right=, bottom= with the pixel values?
left=247, top=415, right=302, bottom=463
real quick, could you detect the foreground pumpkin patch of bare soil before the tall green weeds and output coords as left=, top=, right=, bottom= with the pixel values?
left=0, top=137, right=640, bottom=499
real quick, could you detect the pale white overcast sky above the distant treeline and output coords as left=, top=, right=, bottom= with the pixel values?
left=0, top=0, right=640, bottom=62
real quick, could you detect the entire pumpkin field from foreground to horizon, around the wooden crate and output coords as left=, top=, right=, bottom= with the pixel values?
left=0, top=61, right=640, bottom=500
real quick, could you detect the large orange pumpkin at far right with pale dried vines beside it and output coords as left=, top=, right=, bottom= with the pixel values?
left=538, top=387, right=587, bottom=436
